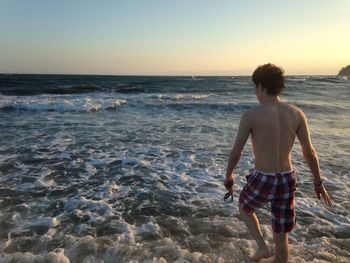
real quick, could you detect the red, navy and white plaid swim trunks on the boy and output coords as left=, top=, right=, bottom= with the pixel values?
left=239, top=169, right=296, bottom=233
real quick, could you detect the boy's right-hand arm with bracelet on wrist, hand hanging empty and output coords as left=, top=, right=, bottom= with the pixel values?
left=297, top=111, right=332, bottom=206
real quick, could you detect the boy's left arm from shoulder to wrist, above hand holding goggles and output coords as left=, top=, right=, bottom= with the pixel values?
left=226, top=112, right=252, bottom=178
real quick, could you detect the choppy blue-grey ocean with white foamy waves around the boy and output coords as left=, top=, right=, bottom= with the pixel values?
left=0, top=74, right=350, bottom=263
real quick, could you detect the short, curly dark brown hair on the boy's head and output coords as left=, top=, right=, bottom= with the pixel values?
left=252, top=63, right=284, bottom=96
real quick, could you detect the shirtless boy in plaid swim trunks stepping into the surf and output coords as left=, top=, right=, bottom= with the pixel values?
left=224, top=64, right=332, bottom=262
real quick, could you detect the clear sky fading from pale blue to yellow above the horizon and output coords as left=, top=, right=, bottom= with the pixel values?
left=0, top=0, right=350, bottom=75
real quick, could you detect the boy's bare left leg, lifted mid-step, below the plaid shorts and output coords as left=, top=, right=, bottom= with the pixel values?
left=239, top=206, right=270, bottom=260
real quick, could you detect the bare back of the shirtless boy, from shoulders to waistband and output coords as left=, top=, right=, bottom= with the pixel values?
left=244, top=102, right=303, bottom=172
